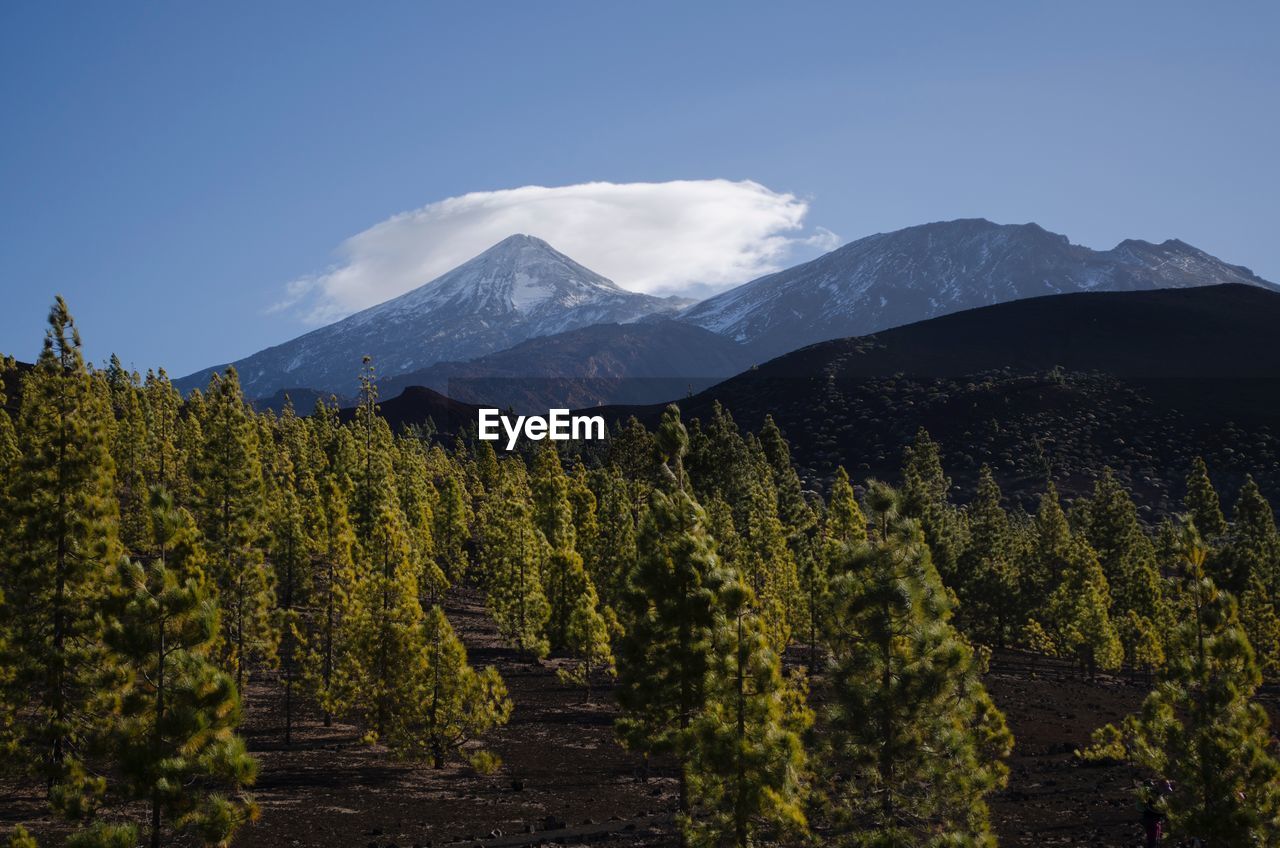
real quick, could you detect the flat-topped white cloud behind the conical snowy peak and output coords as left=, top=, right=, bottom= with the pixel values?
left=273, top=179, right=838, bottom=323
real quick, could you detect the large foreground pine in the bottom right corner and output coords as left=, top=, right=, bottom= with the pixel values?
left=1133, top=528, right=1280, bottom=848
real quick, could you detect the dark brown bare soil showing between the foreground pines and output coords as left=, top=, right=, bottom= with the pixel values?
left=0, top=592, right=1259, bottom=848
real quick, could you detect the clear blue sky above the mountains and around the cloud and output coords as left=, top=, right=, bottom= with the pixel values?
left=0, top=1, right=1280, bottom=374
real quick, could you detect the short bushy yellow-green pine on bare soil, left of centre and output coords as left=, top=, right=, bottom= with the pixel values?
left=387, top=606, right=512, bottom=769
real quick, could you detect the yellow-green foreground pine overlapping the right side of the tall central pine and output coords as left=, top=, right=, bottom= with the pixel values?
left=682, top=579, right=813, bottom=848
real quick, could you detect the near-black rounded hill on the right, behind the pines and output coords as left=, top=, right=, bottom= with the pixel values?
left=595, top=284, right=1280, bottom=512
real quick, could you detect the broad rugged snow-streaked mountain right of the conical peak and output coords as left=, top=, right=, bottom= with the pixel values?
left=681, top=219, right=1270, bottom=357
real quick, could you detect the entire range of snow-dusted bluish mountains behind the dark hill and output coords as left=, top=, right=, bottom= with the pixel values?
left=175, top=219, right=1276, bottom=406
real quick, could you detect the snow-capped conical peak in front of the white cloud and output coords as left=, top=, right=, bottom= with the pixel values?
left=175, top=236, right=687, bottom=398
